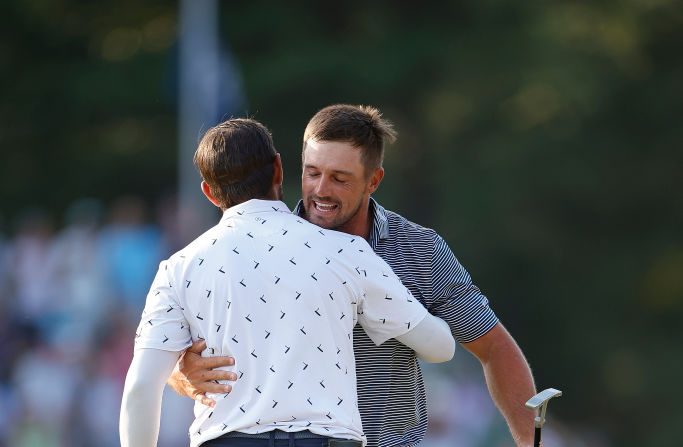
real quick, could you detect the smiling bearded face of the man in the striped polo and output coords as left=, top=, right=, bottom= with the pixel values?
left=301, top=139, right=383, bottom=236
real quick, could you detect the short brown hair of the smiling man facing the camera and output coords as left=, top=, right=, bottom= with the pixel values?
left=302, top=104, right=397, bottom=175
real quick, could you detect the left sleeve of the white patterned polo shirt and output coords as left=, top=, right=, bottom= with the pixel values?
left=135, top=261, right=192, bottom=351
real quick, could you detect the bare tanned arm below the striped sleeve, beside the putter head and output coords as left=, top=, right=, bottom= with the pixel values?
left=463, top=323, right=536, bottom=447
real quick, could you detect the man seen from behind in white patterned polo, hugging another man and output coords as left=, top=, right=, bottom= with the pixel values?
left=120, top=119, right=455, bottom=447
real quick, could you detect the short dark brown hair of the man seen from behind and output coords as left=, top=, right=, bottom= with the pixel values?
left=194, top=118, right=276, bottom=209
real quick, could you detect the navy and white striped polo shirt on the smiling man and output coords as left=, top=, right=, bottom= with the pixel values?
left=295, top=199, right=498, bottom=447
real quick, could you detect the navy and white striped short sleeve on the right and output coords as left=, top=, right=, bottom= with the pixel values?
left=429, top=235, right=498, bottom=343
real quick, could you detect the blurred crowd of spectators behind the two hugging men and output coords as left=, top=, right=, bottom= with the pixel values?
left=0, top=197, right=597, bottom=447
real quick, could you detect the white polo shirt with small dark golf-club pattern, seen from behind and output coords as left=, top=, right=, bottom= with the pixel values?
left=135, top=199, right=427, bottom=446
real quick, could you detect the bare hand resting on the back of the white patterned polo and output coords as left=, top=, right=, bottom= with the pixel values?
left=167, top=340, right=237, bottom=407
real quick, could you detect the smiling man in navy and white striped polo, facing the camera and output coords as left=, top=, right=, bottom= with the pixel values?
left=174, top=105, right=535, bottom=447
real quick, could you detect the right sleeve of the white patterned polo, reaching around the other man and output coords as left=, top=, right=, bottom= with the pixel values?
left=357, top=245, right=427, bottom=346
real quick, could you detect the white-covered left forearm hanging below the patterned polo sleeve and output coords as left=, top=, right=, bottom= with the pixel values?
left=119, top=349, right=180, bottom=447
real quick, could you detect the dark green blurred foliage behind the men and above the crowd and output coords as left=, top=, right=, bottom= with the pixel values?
left=0, top=0, right=683, bottom=446
